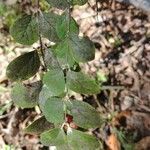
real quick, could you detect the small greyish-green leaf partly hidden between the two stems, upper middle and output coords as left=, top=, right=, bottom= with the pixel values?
left=44, top=49, right=61, bottom=70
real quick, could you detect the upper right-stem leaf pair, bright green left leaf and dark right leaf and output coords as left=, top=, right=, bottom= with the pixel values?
left=56, top=34, right=95, bottom=64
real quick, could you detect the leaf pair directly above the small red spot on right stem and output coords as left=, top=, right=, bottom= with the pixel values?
left=43, top=97, right=102, bottom=129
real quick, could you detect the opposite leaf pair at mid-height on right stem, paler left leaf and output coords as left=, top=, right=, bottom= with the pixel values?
left=43, top=70, right=100, bottom=96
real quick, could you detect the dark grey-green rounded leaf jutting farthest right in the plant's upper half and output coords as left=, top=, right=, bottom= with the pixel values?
left=69, top=34, right=95, bottom=62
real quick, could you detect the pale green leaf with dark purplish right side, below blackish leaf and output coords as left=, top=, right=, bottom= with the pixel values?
left=11, top=82, right=42, bottom=108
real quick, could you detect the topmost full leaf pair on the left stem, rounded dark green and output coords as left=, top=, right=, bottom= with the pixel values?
left=10, top=13, right=58, bottom=45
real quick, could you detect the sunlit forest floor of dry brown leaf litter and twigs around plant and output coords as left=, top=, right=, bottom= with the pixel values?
left=0, top=2, right=150, bottom=150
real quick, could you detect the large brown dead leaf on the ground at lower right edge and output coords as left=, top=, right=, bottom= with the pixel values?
left=112, top=111, right=150, bottom=138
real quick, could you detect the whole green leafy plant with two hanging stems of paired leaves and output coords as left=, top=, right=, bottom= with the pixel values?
left=6, top=0, right=102, bottom=150
